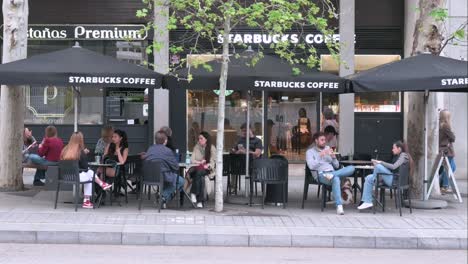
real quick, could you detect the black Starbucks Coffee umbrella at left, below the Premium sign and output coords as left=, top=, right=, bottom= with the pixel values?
left=0, top=43, right=162, bottom=88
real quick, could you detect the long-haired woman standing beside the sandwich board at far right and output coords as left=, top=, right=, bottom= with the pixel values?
left=439, top=110, right=457, bottom=194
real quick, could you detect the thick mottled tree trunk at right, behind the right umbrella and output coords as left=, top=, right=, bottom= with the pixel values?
left=407, top=0, right=445, bottom=198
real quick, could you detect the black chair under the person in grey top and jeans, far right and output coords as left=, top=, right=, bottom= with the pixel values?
left=372, top=163, right=413, bottom=216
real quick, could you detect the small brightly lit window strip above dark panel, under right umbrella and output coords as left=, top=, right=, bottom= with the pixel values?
left=354, top=92, right=401, bottom=112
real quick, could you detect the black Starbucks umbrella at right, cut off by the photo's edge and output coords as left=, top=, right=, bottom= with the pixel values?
left=348, top=54, right=468, bottom=92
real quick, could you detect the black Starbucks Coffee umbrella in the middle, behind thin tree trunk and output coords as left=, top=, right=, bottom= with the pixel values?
left=163, top=52, right=345, bottom=93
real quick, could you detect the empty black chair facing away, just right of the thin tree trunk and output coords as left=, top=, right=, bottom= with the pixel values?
left=250, top=159, right=288, bottom=209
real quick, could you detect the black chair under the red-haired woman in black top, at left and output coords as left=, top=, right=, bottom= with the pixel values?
left=54, top=160, right=94, bottom=212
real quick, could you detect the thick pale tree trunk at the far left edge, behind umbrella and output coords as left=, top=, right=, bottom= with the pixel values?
left=0, top=0, right=29, bottom=190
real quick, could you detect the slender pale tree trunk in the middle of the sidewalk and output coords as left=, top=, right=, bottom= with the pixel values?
left=215, top=15, right=231, bottom=212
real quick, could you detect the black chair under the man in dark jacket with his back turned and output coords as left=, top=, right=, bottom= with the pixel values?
left=138, top=160, right=164, bottom=212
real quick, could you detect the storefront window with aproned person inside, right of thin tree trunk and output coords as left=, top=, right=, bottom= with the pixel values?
left=267, top=92, right=320, bottom=160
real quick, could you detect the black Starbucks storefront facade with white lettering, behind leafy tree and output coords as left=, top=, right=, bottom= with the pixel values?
left=169, top=0, right=404, bottom=162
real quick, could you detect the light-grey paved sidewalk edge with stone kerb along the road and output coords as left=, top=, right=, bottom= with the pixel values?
left=0, top=212, right=467, bottom=249
